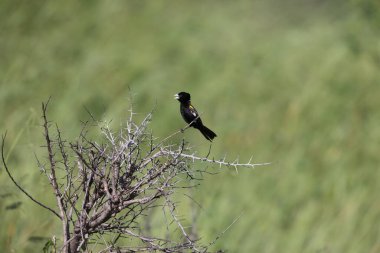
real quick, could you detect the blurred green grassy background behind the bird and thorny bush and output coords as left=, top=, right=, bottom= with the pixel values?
left=0, top=0, right=380, bottom=253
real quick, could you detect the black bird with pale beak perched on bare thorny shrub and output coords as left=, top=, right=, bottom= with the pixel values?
left=174, top=92, right=216, bottom=141
